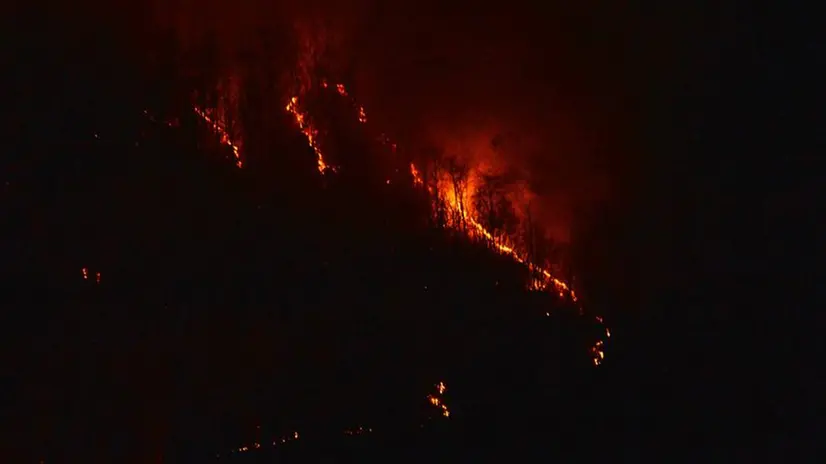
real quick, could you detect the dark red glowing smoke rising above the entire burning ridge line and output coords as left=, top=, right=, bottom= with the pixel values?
left=146, top=0, right=636, bottom=241
